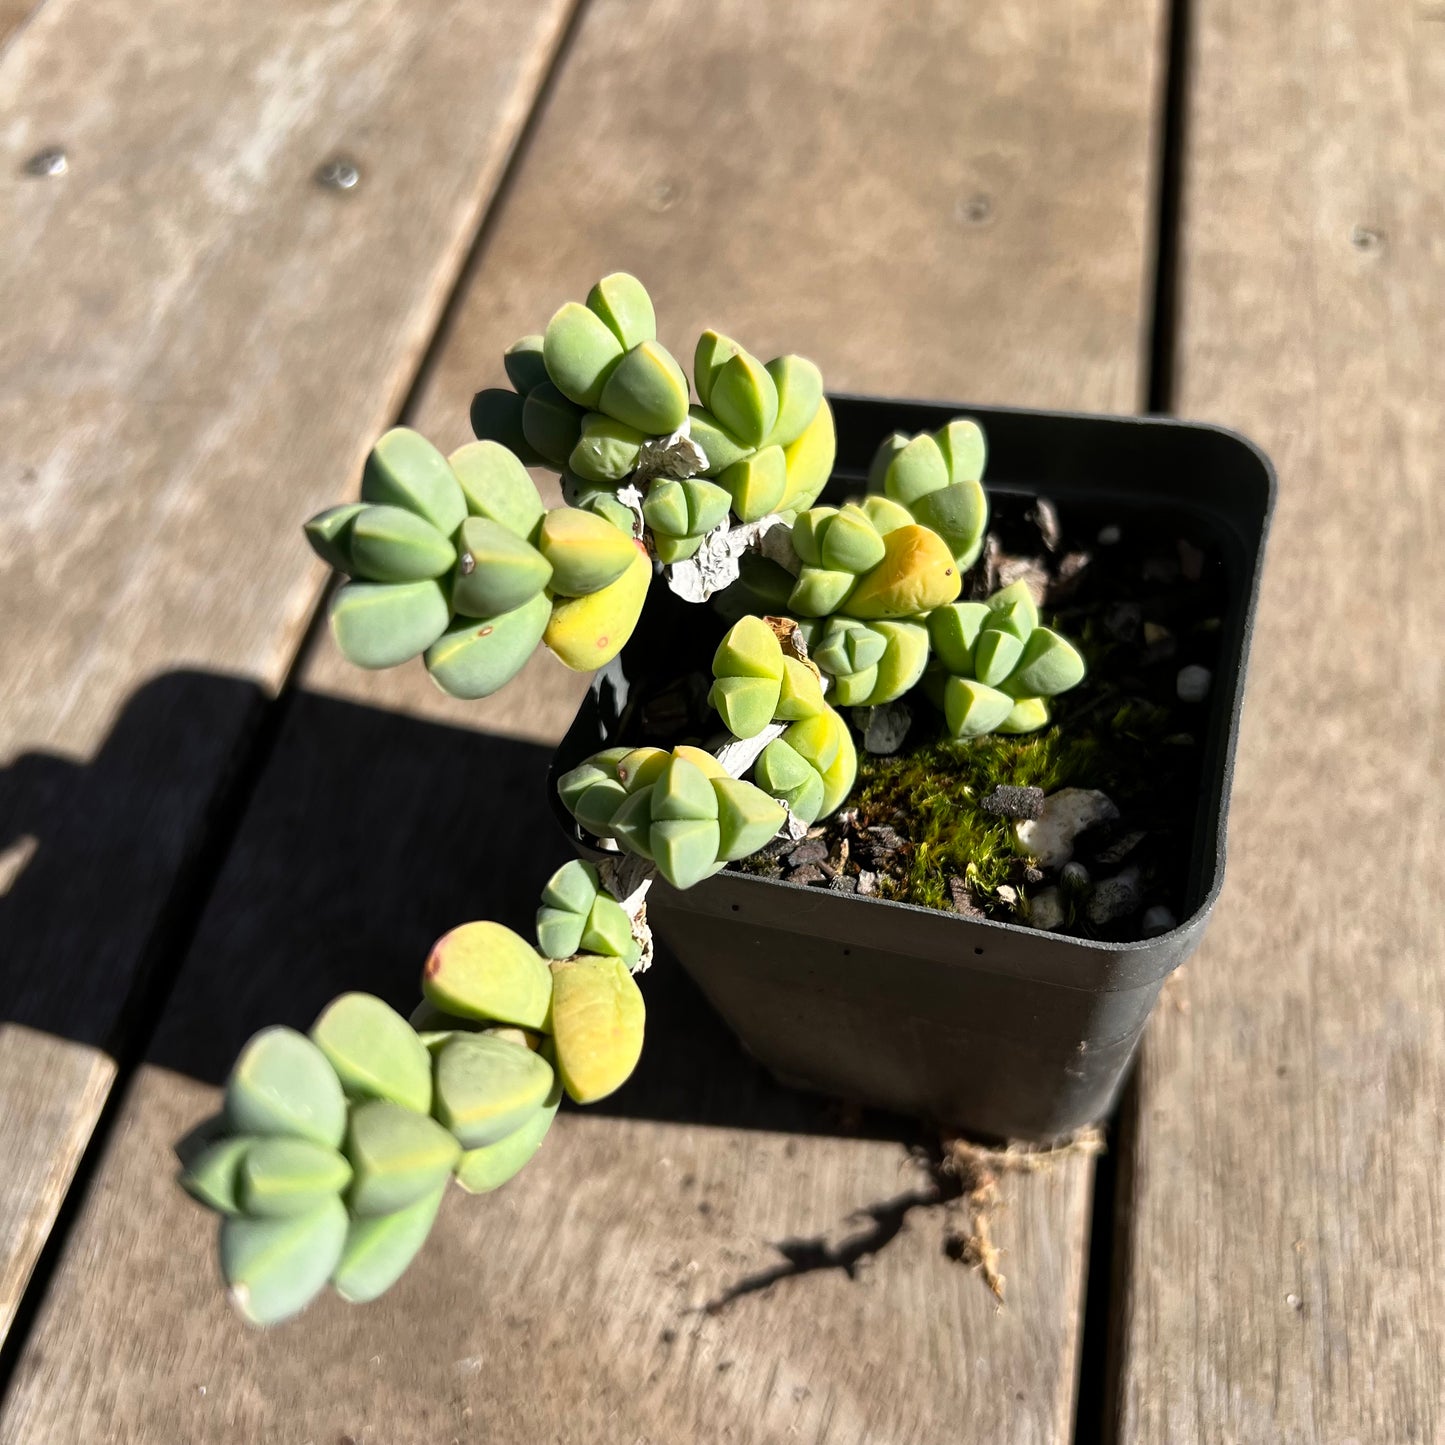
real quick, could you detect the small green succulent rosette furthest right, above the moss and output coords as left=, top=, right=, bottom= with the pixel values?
left=925, top=582, right=1084, bottom=737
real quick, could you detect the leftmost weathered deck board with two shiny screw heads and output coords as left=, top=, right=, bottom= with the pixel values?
left=0, top=0, right=569, bottom=1334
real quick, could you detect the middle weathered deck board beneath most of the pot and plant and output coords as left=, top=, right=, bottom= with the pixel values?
left=0, top=0, right=1159, bottom=1445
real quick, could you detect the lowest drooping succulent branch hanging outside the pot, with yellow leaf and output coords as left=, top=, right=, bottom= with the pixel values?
left=181, top=863, right=644, bottom=1325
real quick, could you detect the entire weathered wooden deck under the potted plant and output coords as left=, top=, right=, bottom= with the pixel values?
left=0, top=0, right=1445, bottom=1445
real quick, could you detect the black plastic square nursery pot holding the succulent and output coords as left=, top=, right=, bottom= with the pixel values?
left=552, top=396, right=1274, bottom=1140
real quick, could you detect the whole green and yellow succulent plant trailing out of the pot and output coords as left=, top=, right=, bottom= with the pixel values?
left=192, top=273, right=1082, bottom=1324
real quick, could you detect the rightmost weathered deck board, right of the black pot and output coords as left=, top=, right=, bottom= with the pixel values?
left=1120, top=0, right=1445, bottom=1445
